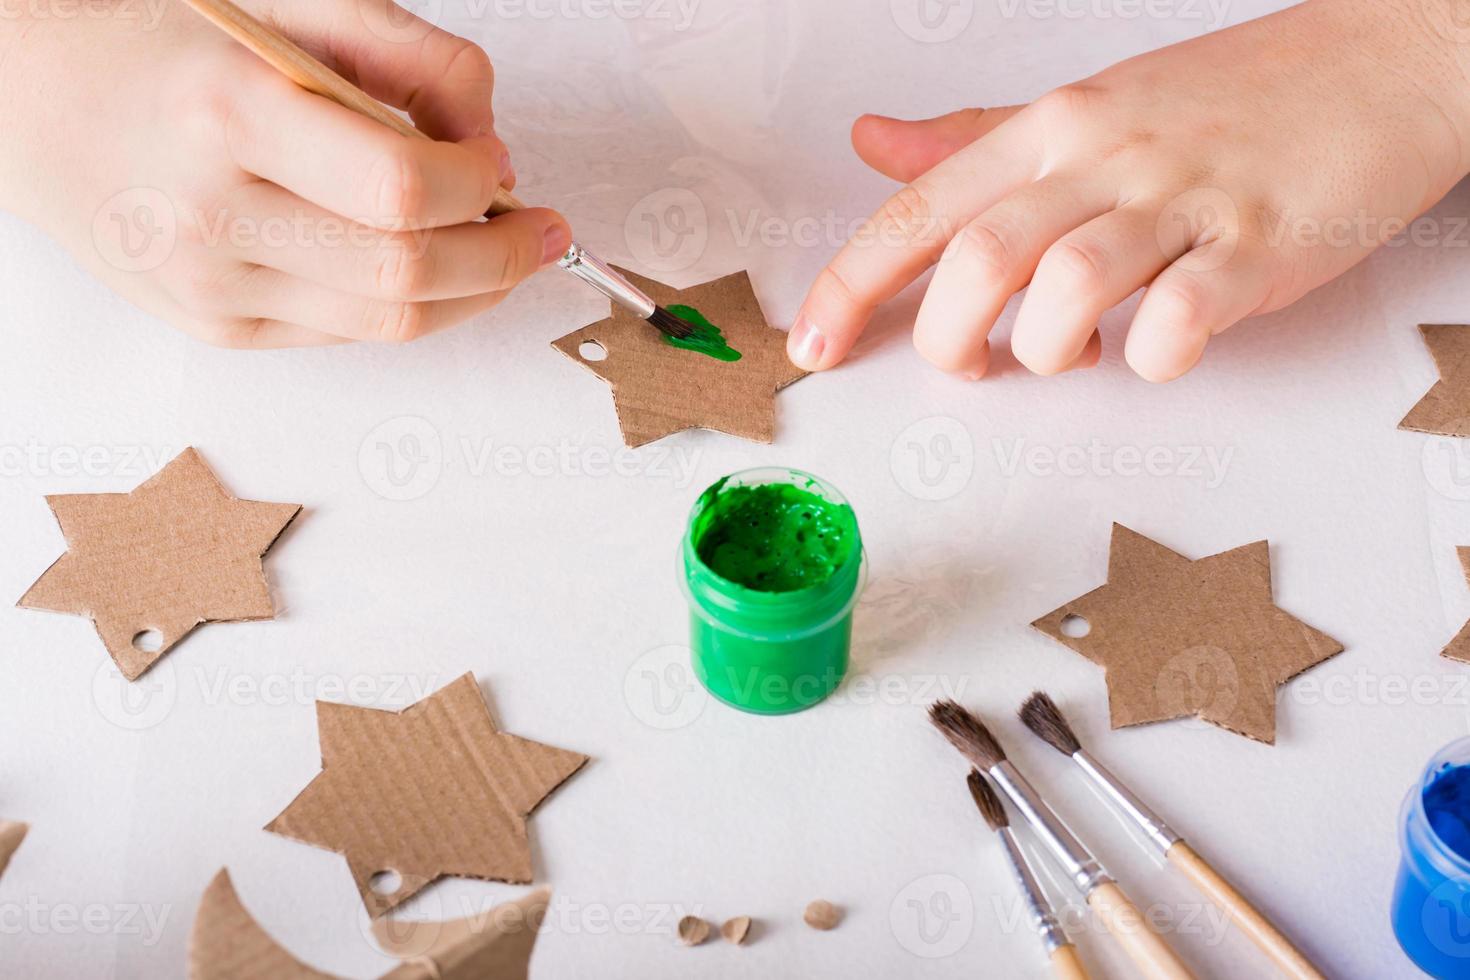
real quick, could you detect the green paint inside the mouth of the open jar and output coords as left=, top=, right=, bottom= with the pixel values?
left=694, top=480, right=857, bottom=592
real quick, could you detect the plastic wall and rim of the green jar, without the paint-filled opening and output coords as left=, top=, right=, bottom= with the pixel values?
left=682, top=469, right=864, bottom=714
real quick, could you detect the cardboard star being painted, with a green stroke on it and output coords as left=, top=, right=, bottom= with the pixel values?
left=551, top=269, right=807, bottom=448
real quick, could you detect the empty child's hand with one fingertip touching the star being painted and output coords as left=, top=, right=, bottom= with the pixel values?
left=789, top=0, right=1470, bottom=381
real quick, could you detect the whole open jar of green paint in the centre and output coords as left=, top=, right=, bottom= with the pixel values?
left=682, top=469, right=866, bottom=714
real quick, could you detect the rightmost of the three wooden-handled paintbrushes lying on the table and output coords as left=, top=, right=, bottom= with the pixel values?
left=1020, top=691, right=1323, bottom=980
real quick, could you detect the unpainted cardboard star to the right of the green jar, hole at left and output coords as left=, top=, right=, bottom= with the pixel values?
left=1032, top=525, right=1342, bottom=743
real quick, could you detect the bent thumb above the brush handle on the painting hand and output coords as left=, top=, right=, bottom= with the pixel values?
left=272, top=0, right=495, bottom=143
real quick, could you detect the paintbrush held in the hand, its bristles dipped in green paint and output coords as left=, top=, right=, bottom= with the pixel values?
left=184, top=0, right=697, bottom=339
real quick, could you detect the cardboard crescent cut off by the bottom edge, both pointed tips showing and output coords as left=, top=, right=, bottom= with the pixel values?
left=188, top=870, right=550, bottom=980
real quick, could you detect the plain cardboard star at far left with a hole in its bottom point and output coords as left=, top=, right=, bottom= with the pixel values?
left=19, top=448, right=301, bottom=680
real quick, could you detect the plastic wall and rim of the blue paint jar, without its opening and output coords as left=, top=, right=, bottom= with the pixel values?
left=1392, top=738, right=1470, bottom=977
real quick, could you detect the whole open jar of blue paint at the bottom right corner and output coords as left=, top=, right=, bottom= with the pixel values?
left=1394, top=738, right=1470, bottom=980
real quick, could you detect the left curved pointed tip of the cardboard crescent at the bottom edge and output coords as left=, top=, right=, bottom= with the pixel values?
left=188, top=868, right=340, bottom=980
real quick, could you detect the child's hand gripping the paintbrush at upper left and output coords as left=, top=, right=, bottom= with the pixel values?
left=0, top=0, right=570, bottom=347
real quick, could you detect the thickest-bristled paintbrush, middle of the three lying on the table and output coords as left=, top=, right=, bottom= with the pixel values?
left=929, top=701, right=1194, bottom=980
